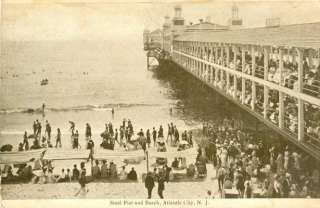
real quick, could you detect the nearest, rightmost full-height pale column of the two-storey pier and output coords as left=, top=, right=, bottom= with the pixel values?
left=296, top=49, right=304, bottom=142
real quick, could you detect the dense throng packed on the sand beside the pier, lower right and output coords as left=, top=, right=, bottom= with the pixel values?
left=203, top=119, right=320, bottom=198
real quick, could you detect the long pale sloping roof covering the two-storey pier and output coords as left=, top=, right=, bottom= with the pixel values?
left=175, top=22, right=320, bottom=49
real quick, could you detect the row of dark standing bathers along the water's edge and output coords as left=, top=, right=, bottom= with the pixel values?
left=14, top=119, right=193, bottom=154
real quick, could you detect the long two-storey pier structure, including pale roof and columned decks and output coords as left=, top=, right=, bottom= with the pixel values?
left=144, top=13, right=320, bottom=159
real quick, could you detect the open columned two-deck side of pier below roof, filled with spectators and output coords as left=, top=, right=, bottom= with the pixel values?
left=172, top=41, right=320, bottom=157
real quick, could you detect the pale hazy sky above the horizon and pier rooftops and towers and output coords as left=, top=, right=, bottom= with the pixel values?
left=1, top=0, right=320, bottom=41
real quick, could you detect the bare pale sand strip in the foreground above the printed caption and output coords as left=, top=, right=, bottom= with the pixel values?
left=1, top=164, right=218, bottom=200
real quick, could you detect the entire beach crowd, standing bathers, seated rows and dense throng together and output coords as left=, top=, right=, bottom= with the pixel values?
left=3, top=110, right=320, bottom=198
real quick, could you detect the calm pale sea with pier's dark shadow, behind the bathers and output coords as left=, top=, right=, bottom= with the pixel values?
left=0, top=41, right=255, bottom=148
